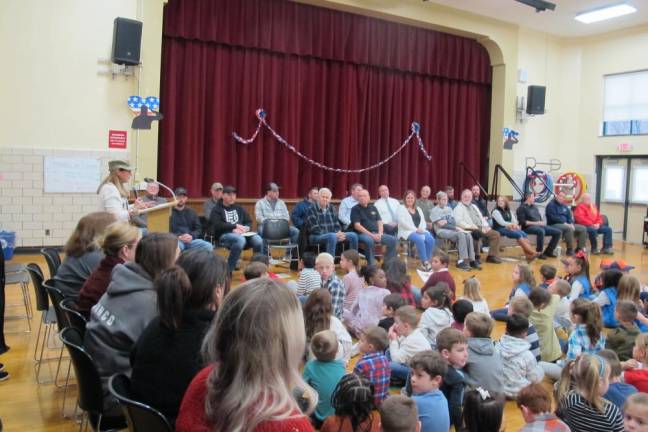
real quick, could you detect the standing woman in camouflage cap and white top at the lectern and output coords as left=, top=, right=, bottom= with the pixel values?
left=97, top=160, right=146, bottom=222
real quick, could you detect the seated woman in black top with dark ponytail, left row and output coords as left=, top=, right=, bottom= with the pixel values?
left=131, top=249, right=229, bottom=424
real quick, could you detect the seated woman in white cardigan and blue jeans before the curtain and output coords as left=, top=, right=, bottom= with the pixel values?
left=396, top=189, right=434, bottom=272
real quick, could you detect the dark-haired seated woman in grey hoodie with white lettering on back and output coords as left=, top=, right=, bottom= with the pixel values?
left=83, top=233, right=180, bottom=409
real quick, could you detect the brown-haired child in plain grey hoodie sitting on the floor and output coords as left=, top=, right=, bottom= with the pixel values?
left=464, top=312, right=504, bottom=393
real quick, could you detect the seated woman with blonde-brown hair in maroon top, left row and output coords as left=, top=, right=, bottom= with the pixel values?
left=77, top=222, right=141, bottom=318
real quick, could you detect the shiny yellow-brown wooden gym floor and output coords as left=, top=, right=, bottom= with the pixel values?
left=0, top=242, right=648, bottom=432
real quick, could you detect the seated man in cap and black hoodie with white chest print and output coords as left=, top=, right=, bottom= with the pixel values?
left=209, top=186, right=263, bottom=272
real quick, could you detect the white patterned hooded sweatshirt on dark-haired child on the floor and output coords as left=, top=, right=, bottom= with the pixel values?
left=499, top=335, right=544, bottom=398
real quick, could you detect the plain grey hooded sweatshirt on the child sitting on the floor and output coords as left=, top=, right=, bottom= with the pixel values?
left=464, top=338, right=506, bottom=393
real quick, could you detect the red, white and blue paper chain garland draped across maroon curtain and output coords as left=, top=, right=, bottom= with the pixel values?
left=232, top=108, right=432, bottom=174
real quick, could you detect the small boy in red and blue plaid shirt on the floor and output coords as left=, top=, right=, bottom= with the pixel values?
left=353, top=326, right=391, bottom=406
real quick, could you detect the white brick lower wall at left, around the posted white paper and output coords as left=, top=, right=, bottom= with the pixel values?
left=0, top=148, right=130, bottom=247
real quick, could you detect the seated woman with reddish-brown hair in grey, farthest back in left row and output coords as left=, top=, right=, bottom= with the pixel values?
left=55, top=212, right=116, bottom=300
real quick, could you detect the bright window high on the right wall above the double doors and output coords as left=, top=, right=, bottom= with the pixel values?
left=603, top=71, right=648, bottom=136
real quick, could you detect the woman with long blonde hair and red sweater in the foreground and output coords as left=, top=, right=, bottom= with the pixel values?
left=176, top=278, right=317, bottom=432
